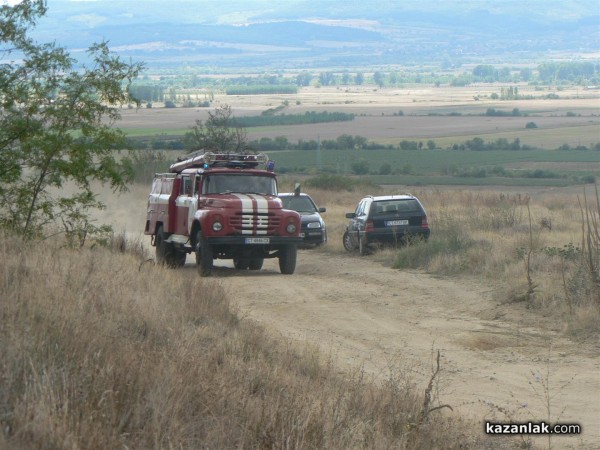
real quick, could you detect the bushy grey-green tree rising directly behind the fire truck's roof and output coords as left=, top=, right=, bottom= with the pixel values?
left=184, top=105, right=251, bottom=152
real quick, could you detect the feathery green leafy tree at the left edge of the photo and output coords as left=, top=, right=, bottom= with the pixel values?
left=0, top=0, right=143, bottom=238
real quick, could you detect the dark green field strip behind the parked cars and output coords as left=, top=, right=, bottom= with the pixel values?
left=269, top=150, right=600, bottom=186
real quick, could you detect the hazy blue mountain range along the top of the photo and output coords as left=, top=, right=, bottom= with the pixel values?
left=30, top=0, right=600, bottom=70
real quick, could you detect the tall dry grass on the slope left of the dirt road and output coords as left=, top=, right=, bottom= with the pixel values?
left=0, top=232, right=502, bottom=449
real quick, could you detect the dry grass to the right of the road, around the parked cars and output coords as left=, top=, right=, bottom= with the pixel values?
left=302, top=183, right=600, bottom=339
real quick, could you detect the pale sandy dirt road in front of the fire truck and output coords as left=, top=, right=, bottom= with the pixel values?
left=198, top=250, right=600, bottom=448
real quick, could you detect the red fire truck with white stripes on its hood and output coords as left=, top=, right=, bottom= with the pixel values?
left=144, top=152, right=302, bottom=276
